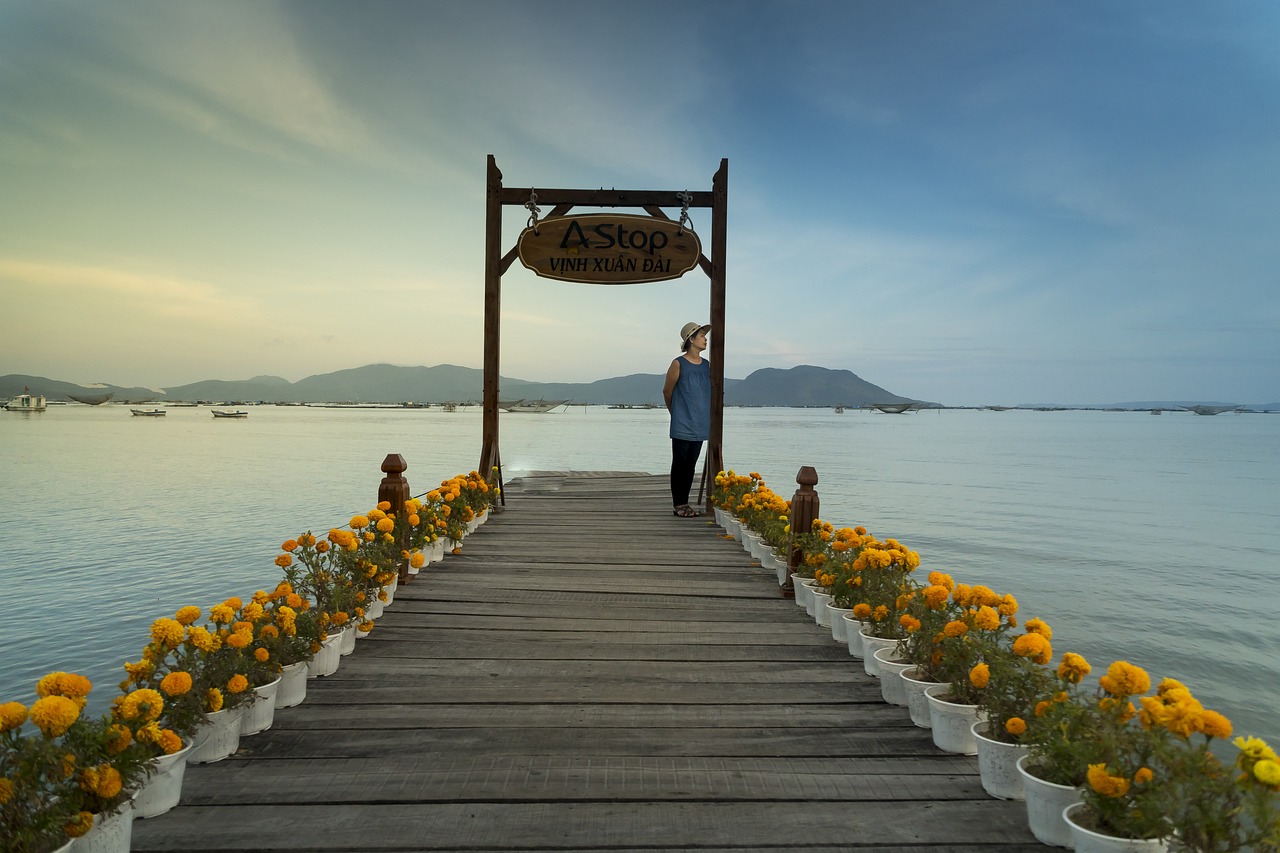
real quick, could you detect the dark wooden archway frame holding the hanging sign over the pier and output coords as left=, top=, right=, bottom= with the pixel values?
left=477, top=154, right=728, bottom=497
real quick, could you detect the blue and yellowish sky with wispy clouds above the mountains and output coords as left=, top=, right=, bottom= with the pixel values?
left=0, top=0, right=1280, bottom=405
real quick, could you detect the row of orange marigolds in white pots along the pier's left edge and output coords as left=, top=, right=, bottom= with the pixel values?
left=0, top=471, right=498, bottom=853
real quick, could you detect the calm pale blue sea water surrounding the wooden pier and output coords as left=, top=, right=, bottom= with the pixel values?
left=0, top=406, right=1280, bottom=743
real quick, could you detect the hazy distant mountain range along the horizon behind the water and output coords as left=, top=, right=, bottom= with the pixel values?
left=0, top=364, right=936, bottom=407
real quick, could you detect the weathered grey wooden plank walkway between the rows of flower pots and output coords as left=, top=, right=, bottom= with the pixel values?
left=133, top=473, right=1043, bottom=853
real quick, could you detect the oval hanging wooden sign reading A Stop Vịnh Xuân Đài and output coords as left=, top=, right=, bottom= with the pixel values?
left=517, top=214, right=703, bottom=284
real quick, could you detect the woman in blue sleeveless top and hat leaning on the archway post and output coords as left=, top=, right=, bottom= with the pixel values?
left=662, top=323, right=712, bottom=519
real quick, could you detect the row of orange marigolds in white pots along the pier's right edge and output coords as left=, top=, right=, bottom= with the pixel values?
left=710, top=471, right=1280, bottom=853
